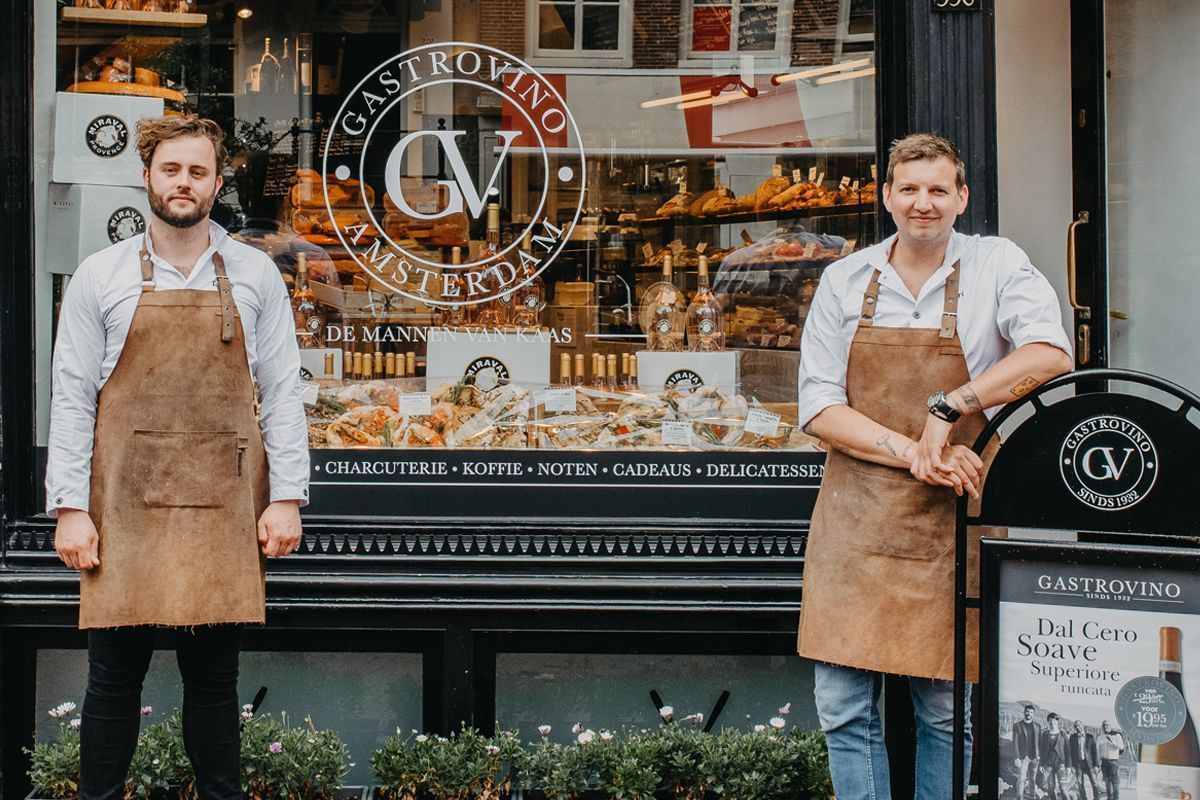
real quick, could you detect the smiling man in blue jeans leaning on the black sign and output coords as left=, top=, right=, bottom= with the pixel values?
left=798, top=133, right=1073, bottom=800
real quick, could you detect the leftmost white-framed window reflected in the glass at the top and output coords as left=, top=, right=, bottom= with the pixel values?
left=527, top=0, right=632, bottom=64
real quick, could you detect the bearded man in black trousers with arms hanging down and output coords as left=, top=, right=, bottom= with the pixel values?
left=46, top=116, right=308, bottom=800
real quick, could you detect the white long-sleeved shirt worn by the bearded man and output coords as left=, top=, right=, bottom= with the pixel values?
left=46, top=222, right=308, bottom=518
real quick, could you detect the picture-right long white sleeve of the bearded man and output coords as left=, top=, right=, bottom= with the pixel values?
left=254, top=265, right=308, bottom=505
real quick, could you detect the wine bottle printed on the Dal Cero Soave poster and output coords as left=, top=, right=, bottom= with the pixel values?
left=1136, top=626, right=1200, bottom=800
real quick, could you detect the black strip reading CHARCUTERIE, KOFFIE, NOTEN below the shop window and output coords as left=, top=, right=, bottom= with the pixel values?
left=305, top=449, right=824, bottom=522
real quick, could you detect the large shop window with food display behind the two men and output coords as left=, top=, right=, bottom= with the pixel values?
left=35, top=0, right=876, bottom=520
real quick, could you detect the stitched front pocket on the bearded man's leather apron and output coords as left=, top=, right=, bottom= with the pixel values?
left=133, top=431, right=241, bottom=509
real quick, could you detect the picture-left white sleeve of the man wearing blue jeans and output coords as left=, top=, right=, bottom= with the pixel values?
left=796, top=267, right=850, bottom=428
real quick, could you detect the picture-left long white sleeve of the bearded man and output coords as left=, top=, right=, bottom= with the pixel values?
left=46, top=263, right=104, bottom=518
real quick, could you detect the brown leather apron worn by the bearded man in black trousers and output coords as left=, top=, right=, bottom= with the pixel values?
left=79, top=243, right=269, bottom=628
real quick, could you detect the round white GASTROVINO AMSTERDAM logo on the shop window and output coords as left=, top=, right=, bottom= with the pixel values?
left=322, top=42, right=587, bottom=307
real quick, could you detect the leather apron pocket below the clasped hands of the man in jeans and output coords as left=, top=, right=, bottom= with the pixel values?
left=846, top=465, right=955, bottom=561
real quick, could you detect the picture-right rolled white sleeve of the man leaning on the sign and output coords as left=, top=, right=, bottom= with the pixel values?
left=996, top=242, right=1073, bottom=355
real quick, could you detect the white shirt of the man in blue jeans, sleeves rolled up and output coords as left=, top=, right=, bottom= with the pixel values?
left=797, top=231, right=1072, bottom=427
